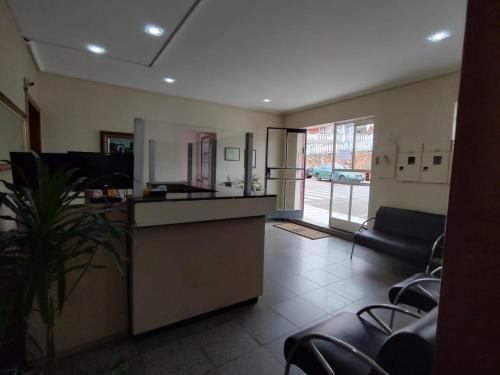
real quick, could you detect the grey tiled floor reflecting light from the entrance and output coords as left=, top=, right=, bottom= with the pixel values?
left=60, top=224, right=416, bottom=375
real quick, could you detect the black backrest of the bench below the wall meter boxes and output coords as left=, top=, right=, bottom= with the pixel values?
left=373, top=206, right=446, bottom=243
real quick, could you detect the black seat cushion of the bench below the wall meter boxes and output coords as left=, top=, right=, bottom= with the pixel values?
left=354, top=230, right=433, bottom=266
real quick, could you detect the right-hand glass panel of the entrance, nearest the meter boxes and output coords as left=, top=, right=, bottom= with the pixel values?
left=330, top=118, right=374, bottom=232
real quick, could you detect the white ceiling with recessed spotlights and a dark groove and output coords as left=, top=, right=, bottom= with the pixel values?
left=9, top=0, right=466, bottom=112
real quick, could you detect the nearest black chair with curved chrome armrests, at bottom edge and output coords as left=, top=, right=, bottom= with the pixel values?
left=284, top=305, right=437, bottom=375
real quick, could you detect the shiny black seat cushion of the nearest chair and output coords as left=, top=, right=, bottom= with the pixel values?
left=284, top=312, right=388, bottom=375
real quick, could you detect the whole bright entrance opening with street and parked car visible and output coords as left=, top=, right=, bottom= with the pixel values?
left=303, top=117, right=374, bottom=232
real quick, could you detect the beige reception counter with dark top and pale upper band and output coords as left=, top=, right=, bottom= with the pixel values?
left=128, top=191, right=276, bottom=334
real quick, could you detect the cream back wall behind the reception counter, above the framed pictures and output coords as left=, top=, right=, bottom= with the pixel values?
left=39, top=73, right=282, bottom=189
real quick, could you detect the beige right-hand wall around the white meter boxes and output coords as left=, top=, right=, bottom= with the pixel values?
left=285, top=73, right=460, bottom=216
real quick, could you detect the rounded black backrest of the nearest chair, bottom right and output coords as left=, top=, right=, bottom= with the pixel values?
left=372, top=307, right=438, bottom=375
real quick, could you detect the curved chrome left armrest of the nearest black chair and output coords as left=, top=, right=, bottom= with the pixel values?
left=285, top=333, right=390, bottom=375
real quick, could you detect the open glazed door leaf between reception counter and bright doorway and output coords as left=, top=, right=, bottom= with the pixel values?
left=264, top=127, right=307, bottom=219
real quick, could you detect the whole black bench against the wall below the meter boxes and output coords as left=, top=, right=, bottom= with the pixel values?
left=351, top=206, right=446, bottom=266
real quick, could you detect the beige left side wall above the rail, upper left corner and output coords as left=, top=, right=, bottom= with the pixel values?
left=0, top=0, right=38, bottom=111
